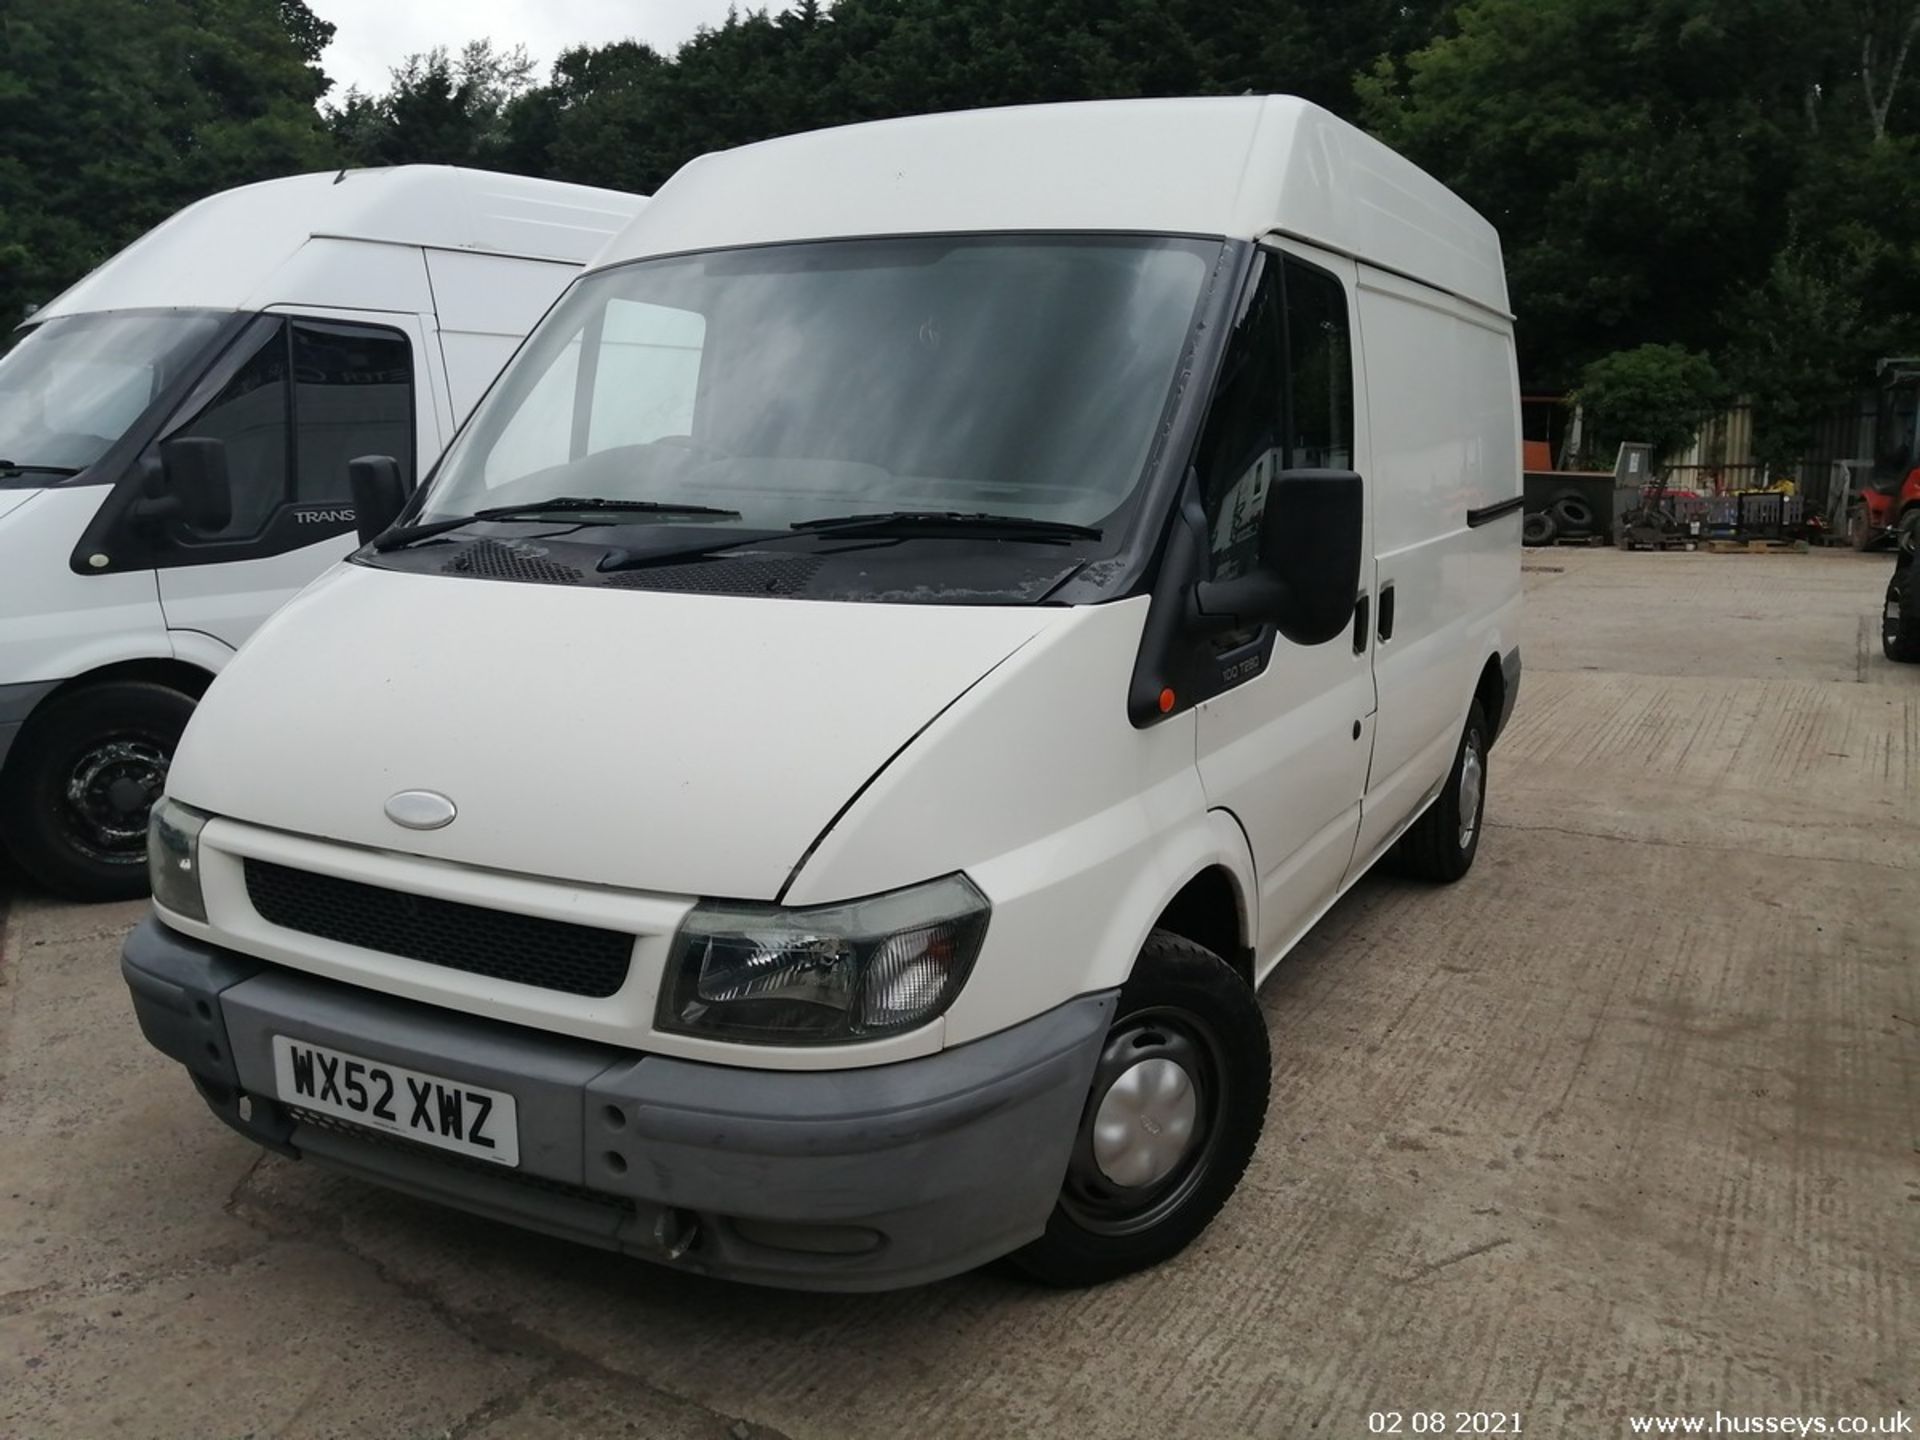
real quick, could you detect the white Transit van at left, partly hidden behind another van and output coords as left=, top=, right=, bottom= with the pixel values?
left=0, top=167, right=643, bottom=899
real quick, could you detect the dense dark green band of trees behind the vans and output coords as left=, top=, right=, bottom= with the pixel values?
left=0, top=0, right=1920, bottom=455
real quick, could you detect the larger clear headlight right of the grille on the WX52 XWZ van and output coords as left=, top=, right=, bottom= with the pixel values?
left=655, top=876, right=991, bottom=1044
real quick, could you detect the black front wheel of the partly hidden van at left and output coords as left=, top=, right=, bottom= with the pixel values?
left=0, top=680, right=194, bottom=900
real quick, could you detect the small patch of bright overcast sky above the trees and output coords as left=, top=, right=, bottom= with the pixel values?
left=307, top=0, right=741, bottom=100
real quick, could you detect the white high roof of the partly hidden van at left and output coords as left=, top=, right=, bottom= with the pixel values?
left=33, top=165, right=645, bottom=321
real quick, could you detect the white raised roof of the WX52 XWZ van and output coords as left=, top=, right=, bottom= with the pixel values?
left=597, top=96, right=1507, bottom=315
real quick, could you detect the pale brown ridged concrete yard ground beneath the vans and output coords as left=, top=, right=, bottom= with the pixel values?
left=0, top=549, right=1920, bottom=1440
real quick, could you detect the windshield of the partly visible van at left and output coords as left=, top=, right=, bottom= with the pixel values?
left=0, top=311, right=221, bottom=486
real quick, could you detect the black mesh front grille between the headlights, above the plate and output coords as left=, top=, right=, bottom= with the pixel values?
left=246, top=860, right=634, bottom=998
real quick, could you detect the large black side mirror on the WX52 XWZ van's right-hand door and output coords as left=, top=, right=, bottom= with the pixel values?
left=1194, top=470, right=1367, bottom=645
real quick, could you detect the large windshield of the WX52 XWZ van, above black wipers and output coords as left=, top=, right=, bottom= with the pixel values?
left=420, top=236, right=1221, bottom=540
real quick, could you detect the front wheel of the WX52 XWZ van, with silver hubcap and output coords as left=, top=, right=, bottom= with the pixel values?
left=1010, top=929, right=1273, bottom=1286
